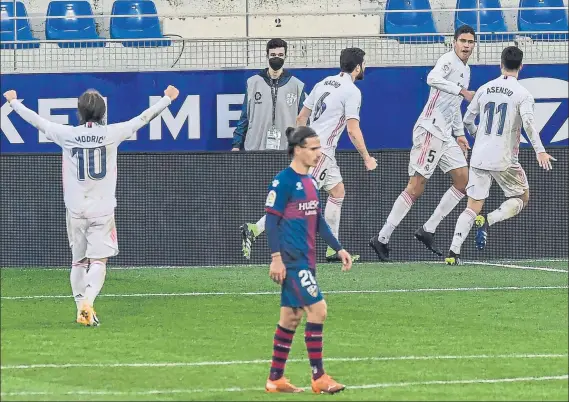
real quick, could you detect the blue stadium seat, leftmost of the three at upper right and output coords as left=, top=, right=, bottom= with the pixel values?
left=384, top=0, right=444, bottom=43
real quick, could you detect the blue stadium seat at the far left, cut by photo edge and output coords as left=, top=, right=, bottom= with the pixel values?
left=0, top=1, right=40, bottom=49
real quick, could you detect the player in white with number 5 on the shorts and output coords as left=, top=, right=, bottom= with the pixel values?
left=369, top=25, right=476, bottom=261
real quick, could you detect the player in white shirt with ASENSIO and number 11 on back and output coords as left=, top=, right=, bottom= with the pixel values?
left=445, top=46, right=555, bottom=265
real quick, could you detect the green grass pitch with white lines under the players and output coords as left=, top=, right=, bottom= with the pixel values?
left=1, top=261, right=568, bottom=401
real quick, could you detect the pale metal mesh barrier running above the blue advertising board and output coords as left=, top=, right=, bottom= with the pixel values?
left=0, top=32, right=569, bottom=74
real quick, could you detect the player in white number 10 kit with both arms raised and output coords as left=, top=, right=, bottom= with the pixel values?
left=4, top=86, right=179, bottom=326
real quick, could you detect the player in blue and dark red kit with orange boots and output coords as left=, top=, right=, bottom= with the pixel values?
left=265, top=127, right=352, bottom=394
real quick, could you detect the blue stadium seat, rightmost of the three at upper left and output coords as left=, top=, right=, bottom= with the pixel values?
left=111, top=0, right=171, bottom=47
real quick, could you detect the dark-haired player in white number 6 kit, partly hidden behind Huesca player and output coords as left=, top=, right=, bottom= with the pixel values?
left=242, top=48, right=377, bottom=262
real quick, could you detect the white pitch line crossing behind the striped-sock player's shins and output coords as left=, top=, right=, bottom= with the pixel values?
left=0, top=354, right=569, bottom=370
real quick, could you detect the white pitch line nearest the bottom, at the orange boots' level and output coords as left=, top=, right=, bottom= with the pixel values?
left=0, top=374, right=569, bottom=396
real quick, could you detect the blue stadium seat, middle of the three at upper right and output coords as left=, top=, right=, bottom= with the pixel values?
left=454, top=0, right=514, bottom=42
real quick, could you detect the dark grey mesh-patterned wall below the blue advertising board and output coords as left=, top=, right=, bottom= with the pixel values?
left=0, top=147, right=569, bottom=267
